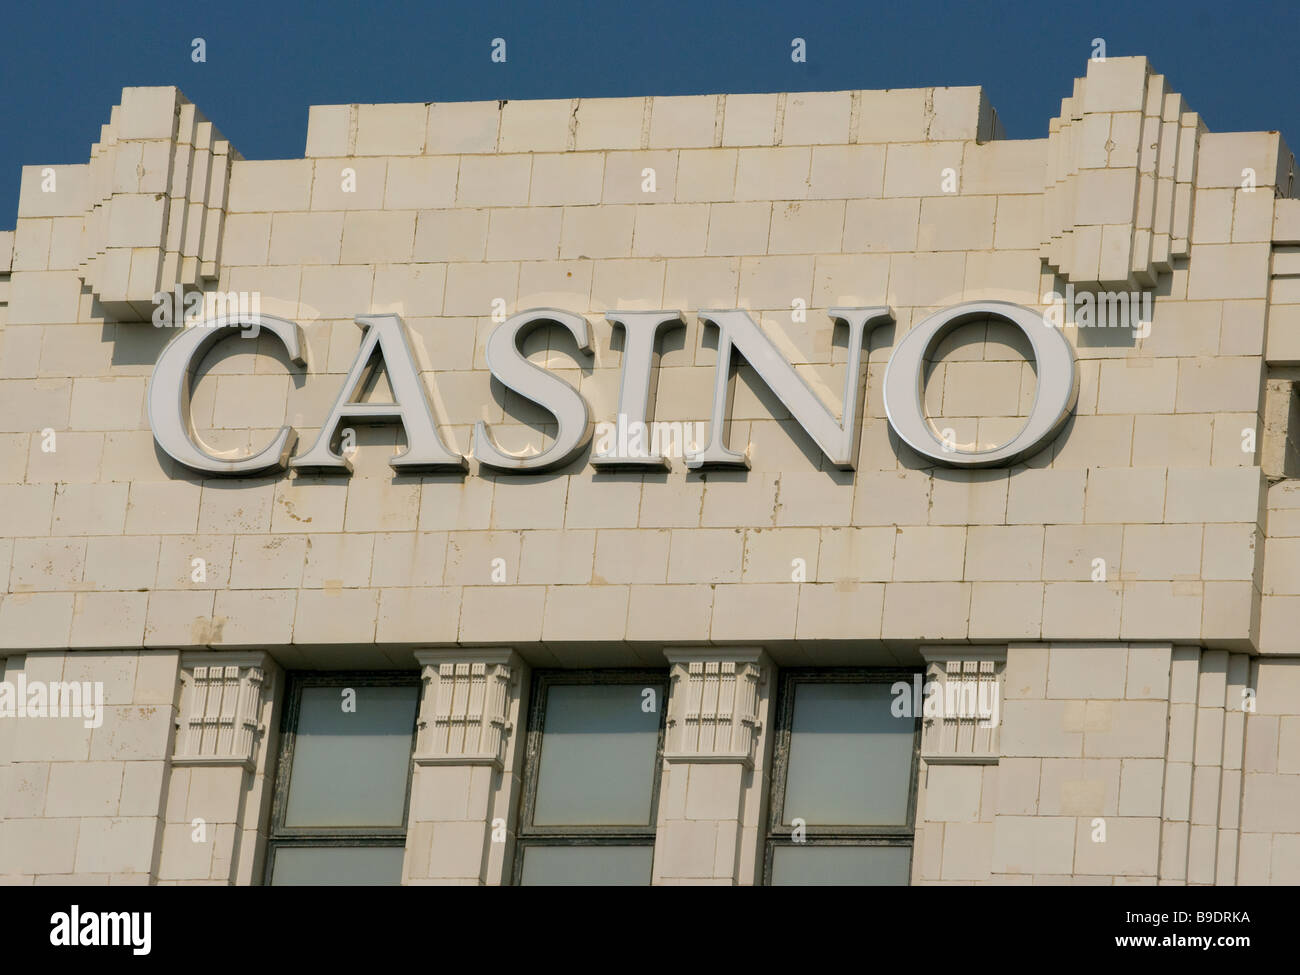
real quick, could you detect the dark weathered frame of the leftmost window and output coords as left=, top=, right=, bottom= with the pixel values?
left=261, top=671, right=421, bottom=887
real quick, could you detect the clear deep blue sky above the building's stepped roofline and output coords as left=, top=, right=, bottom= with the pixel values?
left=0, top=0, right=1300, bottom=229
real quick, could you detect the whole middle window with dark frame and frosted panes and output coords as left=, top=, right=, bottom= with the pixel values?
left=515, top=671, right=668, bottom=885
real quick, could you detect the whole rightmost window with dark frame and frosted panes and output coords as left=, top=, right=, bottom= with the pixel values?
left=766, top=670, right=920, bottom=885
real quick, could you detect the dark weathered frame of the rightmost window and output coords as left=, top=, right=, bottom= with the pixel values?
left=763, top=667, right=926, bottom=887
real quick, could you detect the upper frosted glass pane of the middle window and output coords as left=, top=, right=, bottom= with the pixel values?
left=533, top=684, right=663, bottom=826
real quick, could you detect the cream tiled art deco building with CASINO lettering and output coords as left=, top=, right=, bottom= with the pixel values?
left=0, top=57, right=1300, bottom=884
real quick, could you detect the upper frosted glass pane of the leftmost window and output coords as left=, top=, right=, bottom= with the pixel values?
left=283, top=684, right=419, bottom=828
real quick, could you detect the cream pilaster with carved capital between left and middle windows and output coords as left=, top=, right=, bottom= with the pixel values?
left=402, top=649, right=528, bottom=884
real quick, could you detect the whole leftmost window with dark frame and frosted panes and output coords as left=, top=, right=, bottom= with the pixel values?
left=267, top=673, right=420, bottom=885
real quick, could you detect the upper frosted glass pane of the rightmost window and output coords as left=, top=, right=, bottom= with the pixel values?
left=783, top=683, right=915, bottom=826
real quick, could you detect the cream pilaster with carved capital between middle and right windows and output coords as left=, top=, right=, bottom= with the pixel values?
left=654, top=647, right=772, bottom=884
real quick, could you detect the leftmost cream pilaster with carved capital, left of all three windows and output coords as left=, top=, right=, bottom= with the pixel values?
left=159, top=653, right=280, bottom=884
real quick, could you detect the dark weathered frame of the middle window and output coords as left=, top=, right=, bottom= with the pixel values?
left=511, top=667, right=672, bottom=887
